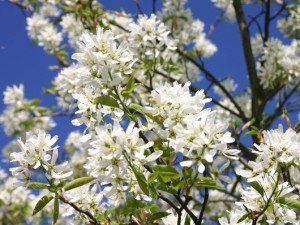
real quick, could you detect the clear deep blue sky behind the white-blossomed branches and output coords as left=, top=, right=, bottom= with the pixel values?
left=0, top=0, right=290, bottom=164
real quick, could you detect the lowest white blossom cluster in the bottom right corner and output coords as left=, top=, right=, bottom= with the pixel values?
left=219, top=176, right=299, bottom=225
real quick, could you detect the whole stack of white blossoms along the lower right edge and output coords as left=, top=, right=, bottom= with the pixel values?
left=220, top=126, right=300, bottom=225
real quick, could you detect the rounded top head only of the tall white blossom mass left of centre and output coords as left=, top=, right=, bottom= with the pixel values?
left=72, top=27, right=135, bottom=87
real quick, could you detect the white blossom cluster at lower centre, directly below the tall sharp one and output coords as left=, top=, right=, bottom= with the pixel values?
left=84, top=121, right=162, bottom=204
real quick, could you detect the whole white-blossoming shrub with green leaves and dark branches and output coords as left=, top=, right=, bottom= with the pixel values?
left=0, top=0, right=300, bottom=225
